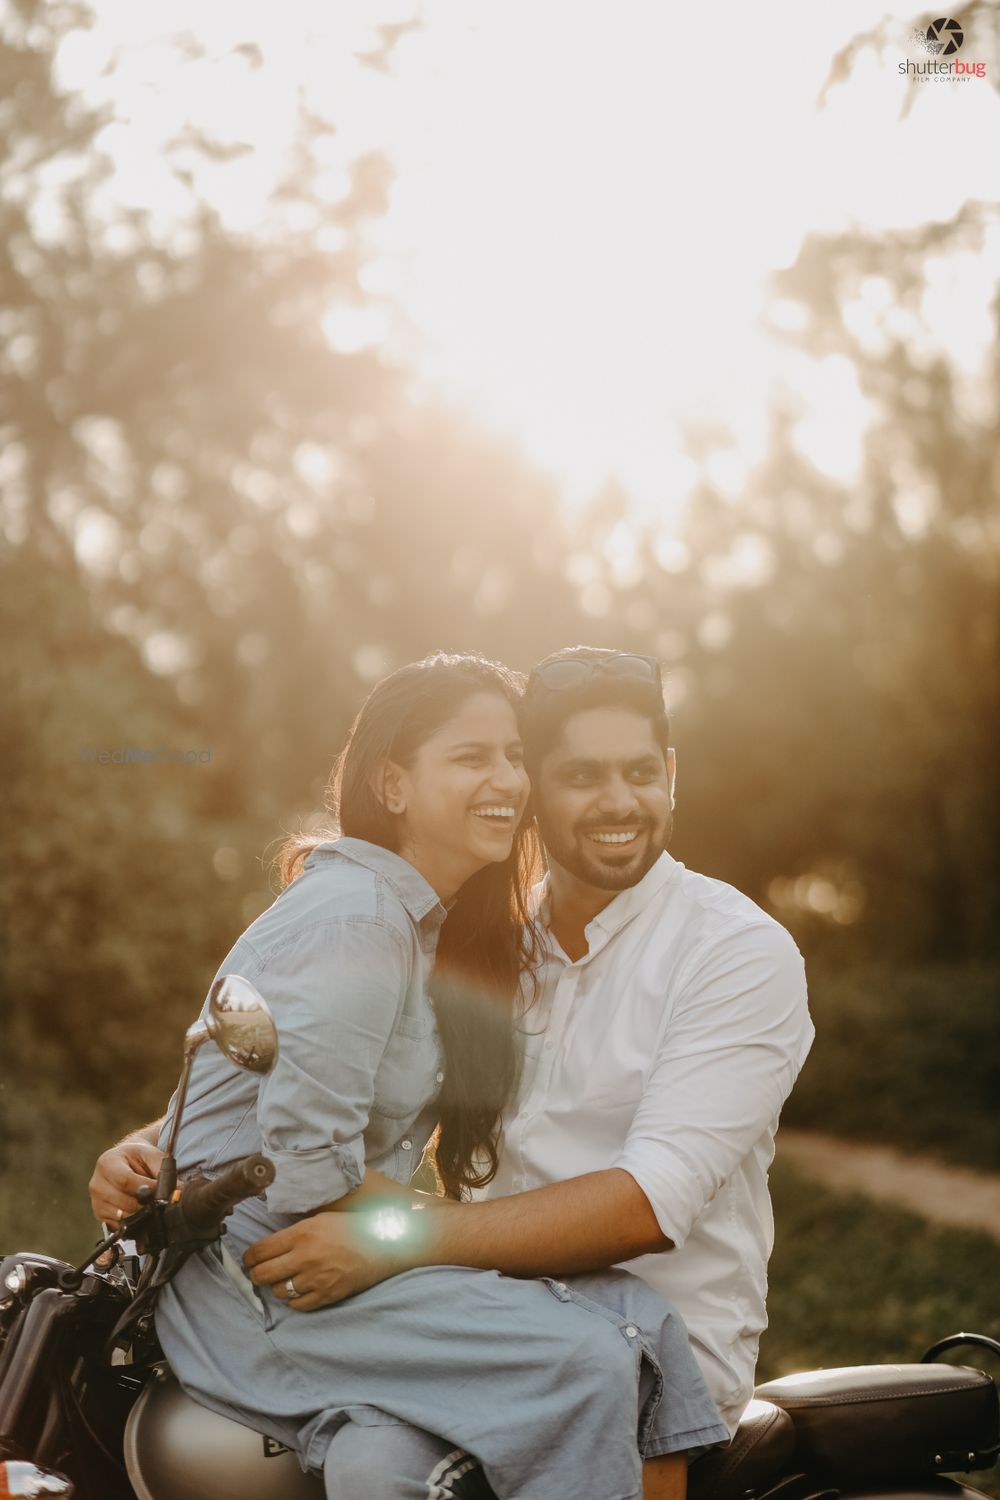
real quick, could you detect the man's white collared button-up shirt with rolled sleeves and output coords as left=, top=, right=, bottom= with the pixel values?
left=487, top=854, right=814, bottom=1428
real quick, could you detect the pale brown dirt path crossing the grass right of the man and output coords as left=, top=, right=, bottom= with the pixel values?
left=777, top=1130, right=1000, bottom=1241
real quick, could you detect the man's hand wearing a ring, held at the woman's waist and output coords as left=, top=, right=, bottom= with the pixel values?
left=243, top=1208, right=413, bottom=1313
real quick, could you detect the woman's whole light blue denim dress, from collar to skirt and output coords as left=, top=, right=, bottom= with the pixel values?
left=156, top=839, right=729, bottom=1500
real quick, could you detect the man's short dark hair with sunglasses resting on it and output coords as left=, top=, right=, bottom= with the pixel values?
left=517, top=647, right=670, bottom=780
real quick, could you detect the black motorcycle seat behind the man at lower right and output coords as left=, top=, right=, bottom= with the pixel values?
left=756, top=1364, right=1000, bottom=1484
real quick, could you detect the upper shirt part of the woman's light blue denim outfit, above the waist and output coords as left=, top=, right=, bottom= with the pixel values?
left=160, top=839, right=445, bottom=1239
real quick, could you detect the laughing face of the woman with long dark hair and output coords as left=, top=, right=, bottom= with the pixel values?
left=384, top=690, right=529, bottom=900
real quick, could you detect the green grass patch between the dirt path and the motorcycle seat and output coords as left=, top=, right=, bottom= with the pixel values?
left=757, top=1164, right=1000, bottom=1497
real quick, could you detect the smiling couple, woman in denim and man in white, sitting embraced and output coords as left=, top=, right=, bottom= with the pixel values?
left=91, top=647, right=813, bottom=1500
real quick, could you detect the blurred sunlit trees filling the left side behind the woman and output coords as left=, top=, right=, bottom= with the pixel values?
left=0, top=0, right=587, bottom=1128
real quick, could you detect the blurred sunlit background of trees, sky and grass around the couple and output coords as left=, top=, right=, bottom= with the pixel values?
left=0, top=0, right=1000, bottom=1428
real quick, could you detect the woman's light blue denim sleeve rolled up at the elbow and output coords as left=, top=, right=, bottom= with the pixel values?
left=255, top=918, right=411, bottom=1214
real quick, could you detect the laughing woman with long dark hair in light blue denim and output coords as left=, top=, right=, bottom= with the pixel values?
left=91, top=657, right=727, bottom=1500
